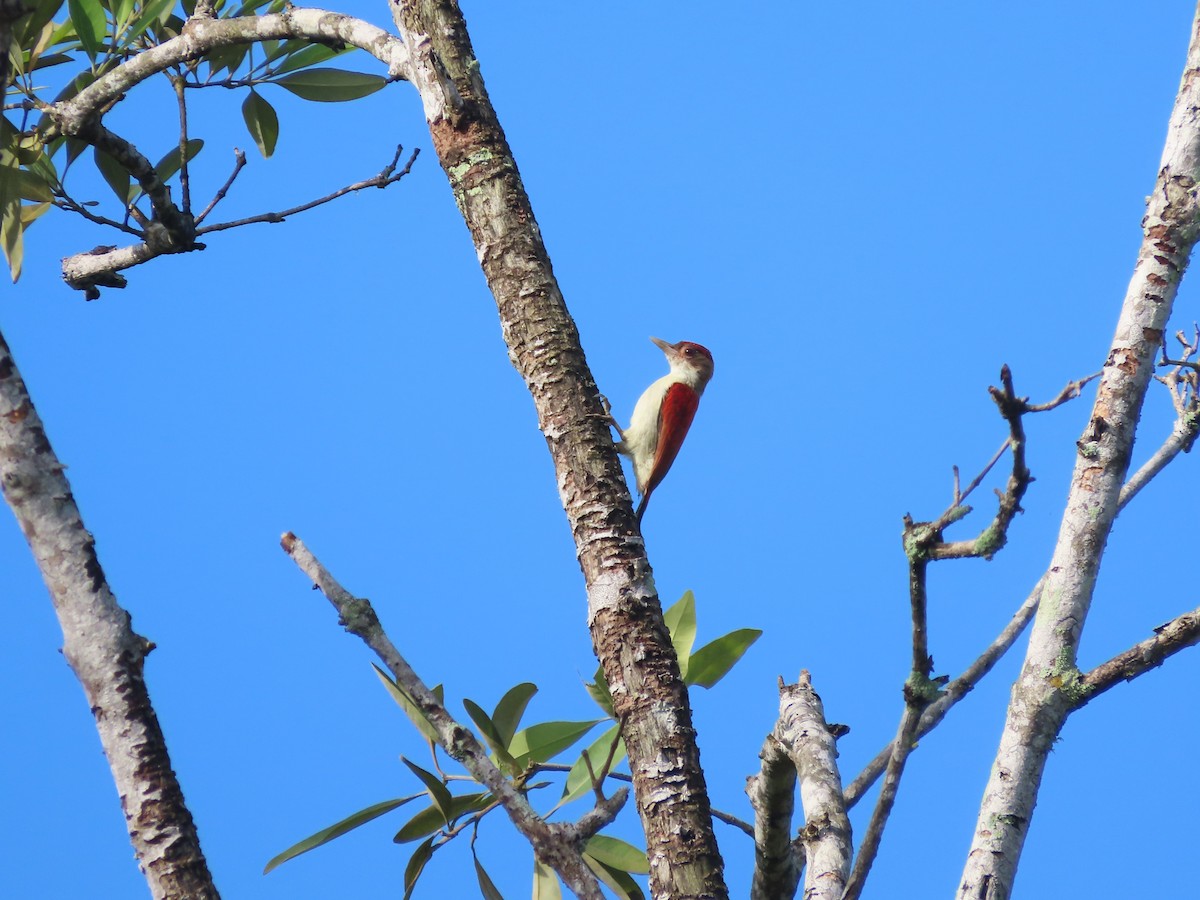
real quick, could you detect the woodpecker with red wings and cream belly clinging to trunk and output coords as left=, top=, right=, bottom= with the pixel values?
left=613, top=337, right=713, bottom=524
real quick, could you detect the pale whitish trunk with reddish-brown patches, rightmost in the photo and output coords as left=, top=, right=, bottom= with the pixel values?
left=958, top=8, right=1200, bottom=900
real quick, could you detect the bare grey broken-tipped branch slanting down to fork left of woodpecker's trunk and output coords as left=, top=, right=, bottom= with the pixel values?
left=281, top=532, right=604, bottom=900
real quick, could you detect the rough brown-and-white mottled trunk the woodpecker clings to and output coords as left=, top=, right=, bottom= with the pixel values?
left=394, top=0, right=726, bottom=899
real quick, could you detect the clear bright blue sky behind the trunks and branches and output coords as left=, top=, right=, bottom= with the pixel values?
left=0, top=0, right=1200, bottom=900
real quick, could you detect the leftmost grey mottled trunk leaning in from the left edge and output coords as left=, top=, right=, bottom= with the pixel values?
left=0, top=336, right=217, bottom=900
